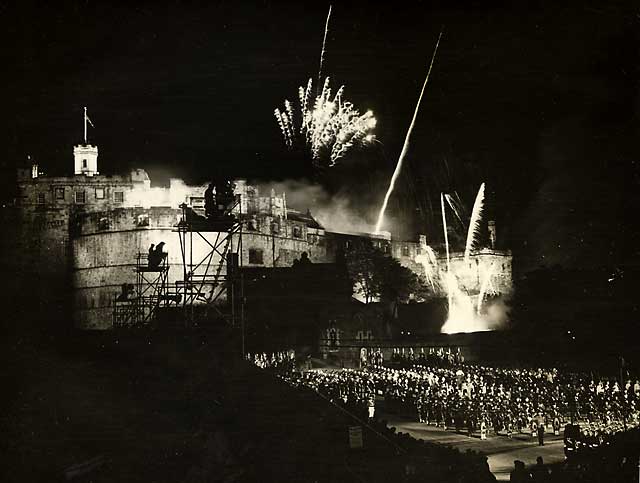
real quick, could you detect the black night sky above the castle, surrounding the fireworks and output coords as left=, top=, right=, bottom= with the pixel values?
left=0, top=1, right=640, bottom=268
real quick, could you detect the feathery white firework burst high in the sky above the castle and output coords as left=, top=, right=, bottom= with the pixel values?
left=274, top=77, right=376, bottom=167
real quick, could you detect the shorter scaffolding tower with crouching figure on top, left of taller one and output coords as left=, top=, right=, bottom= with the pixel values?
left=113, top=253, right=179, bottom=328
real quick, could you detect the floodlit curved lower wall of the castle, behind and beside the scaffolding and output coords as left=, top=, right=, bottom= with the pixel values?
left=72, top=208, right=336, bottom=329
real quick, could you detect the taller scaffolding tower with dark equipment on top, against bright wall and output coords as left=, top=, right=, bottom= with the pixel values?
left=175, top=196, right=243, bottom=328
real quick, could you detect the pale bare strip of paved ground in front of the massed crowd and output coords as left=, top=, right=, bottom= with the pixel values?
left=380, top=414, right=564, bottom=481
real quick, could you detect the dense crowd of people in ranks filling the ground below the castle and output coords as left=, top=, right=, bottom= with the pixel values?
left=249, top=349, right=640, bottom=481
